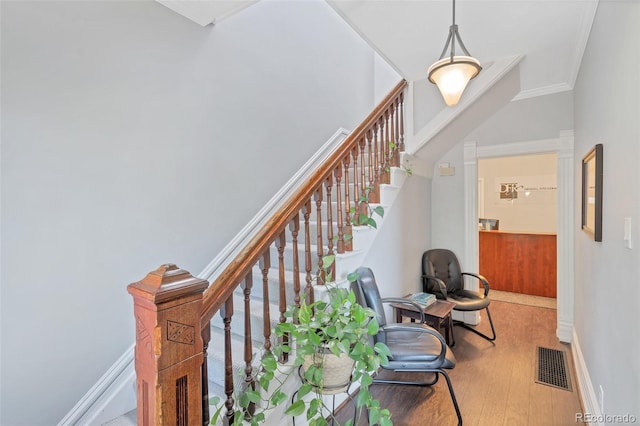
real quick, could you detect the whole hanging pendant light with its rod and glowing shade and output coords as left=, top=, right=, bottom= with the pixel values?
left=428, top=0, right=482, bottom=106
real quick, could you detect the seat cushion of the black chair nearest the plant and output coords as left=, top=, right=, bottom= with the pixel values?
left=385, top=331, right=456, bottom=370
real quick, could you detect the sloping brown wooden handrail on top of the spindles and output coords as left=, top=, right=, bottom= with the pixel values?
left=201, top=80, right=407, bottom=327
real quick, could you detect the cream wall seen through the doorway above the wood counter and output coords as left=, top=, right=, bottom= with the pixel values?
left=478, top=153, right=558, bottom=234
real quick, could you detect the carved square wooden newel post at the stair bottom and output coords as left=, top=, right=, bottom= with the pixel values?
left=127, top=264, right=209, bottom=426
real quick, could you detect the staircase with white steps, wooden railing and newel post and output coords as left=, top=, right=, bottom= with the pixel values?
left=110, top=81, right=407, bottom=425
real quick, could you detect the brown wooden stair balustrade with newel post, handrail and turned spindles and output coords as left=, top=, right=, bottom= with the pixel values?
left=129, top=81, right=407, bottom=426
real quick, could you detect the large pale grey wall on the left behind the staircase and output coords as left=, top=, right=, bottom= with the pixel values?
left=0, top=0, right=374, bottom=426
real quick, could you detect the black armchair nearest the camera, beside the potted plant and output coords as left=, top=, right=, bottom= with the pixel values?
left=352, top=267, right=462, bottom=425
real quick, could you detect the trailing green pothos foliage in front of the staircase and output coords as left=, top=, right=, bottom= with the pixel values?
left=210, top=192, right=393, bottom=426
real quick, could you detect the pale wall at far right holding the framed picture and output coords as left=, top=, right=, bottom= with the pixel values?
left=574, top=0, right=640, bottom=419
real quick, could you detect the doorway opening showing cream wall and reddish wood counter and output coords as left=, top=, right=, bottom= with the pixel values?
left=478, top=153, right=558, bottom=302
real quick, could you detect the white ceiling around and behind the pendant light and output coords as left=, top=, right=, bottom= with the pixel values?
left=158, top=0, right=598, bottom=98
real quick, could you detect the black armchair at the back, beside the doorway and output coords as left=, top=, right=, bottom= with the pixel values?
left=422, top=249, right=496, bottom=342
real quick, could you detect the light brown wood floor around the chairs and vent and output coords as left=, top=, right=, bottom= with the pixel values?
left=338, top=301, right=582, bottom=426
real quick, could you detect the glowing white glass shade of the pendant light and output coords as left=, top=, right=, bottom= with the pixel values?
left=428, top=56, right=482, bottom=106
